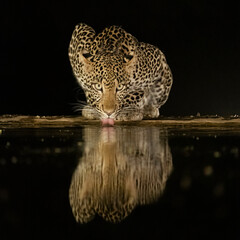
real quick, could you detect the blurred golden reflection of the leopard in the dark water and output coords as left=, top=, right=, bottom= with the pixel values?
left=69, top=127, right=172, bottom=223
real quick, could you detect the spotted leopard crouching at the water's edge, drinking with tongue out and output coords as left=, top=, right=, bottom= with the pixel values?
left=68, top=23, right=173, bottom=121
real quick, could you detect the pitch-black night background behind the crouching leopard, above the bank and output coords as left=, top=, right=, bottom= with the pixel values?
left=0, top=0, right=240, bottom=116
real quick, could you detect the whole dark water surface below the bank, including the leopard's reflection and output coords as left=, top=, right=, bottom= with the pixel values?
left=0, top=126, right=240, bottom=239
